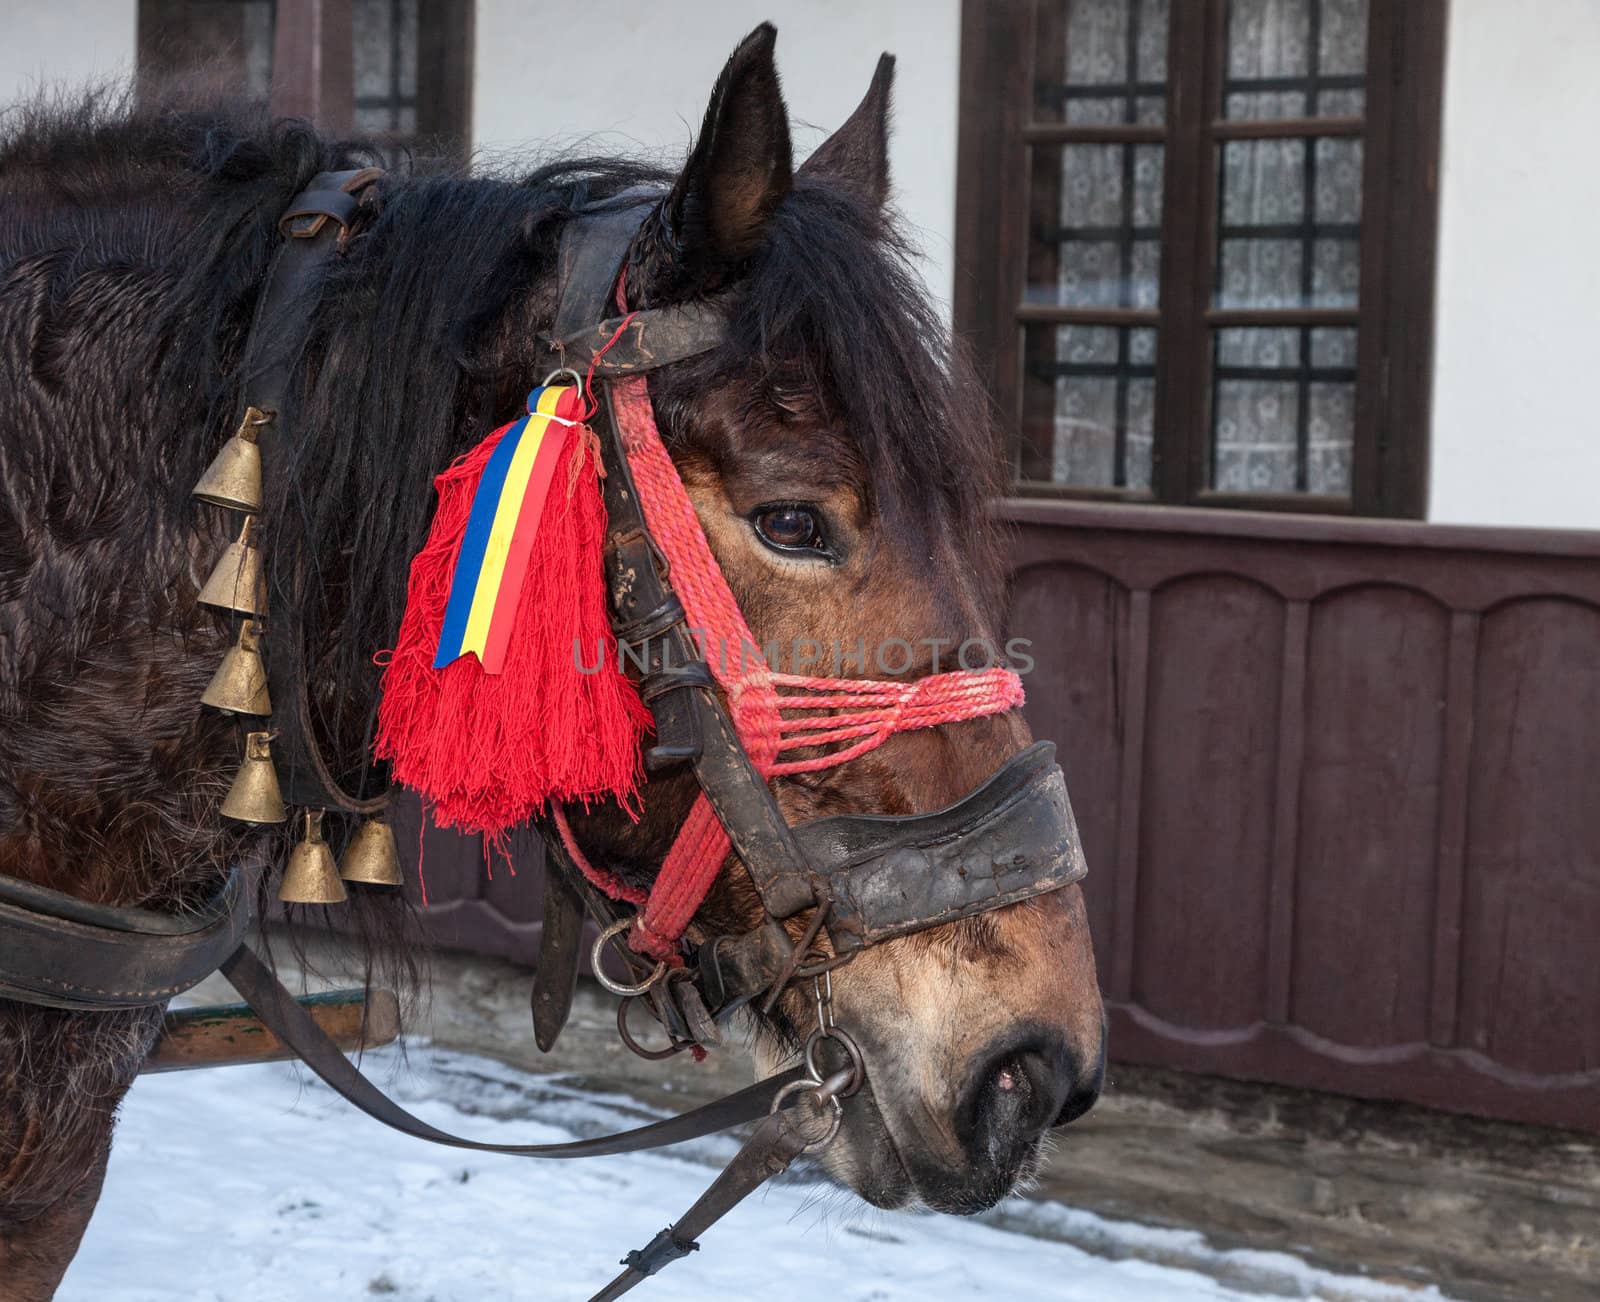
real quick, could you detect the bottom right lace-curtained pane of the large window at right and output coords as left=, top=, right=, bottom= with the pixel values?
left=1210, top=326, right=1355, bottom=494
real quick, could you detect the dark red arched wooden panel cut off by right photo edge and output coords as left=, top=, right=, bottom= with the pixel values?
left=1461, top=600, right=1600, bottom=1081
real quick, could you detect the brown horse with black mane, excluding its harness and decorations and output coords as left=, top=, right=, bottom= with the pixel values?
left=0, top=26, right=1104, bottom=1302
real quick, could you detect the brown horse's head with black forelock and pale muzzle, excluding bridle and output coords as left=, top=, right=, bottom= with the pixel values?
left=560, top=27, right=1104, bottom=1211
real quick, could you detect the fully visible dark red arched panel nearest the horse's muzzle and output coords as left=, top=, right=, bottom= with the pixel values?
left=1134, top=574, right=1283, bottom=1028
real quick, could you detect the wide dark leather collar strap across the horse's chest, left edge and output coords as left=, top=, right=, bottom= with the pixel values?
left=0, top=869, right=251, bottom=1012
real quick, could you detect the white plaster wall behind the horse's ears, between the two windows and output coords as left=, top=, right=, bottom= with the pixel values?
left=472, top=0, right=960, bottom=304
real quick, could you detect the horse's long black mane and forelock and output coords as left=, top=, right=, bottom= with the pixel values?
left=0, top=86, right=998, bottom=825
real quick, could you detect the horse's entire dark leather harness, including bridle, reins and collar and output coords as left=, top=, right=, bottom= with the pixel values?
left=0, top=170, right=1086, bottom=1299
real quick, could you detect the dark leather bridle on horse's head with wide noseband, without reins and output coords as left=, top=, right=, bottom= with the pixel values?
left=534, top=195, right=1086, bottom=1046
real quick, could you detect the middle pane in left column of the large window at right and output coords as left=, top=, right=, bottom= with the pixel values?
left=1027, top=144, right=1163, bottom=307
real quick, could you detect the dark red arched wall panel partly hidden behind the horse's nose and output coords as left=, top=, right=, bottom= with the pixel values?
left=1006, top=565, right=1128, bottom=971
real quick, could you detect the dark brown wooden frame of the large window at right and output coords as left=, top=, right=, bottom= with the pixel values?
left=955, top=0, right=1446, bottom=518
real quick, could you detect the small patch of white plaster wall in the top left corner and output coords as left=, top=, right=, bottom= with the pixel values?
left=0, top=0, right=139, bottom=109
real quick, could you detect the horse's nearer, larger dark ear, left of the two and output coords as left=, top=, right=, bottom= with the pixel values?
left=666, top=22, right=794, bottom=272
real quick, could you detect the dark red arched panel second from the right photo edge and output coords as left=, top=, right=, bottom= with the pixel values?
left=1290, top=585, right=1450, bottom=1048
